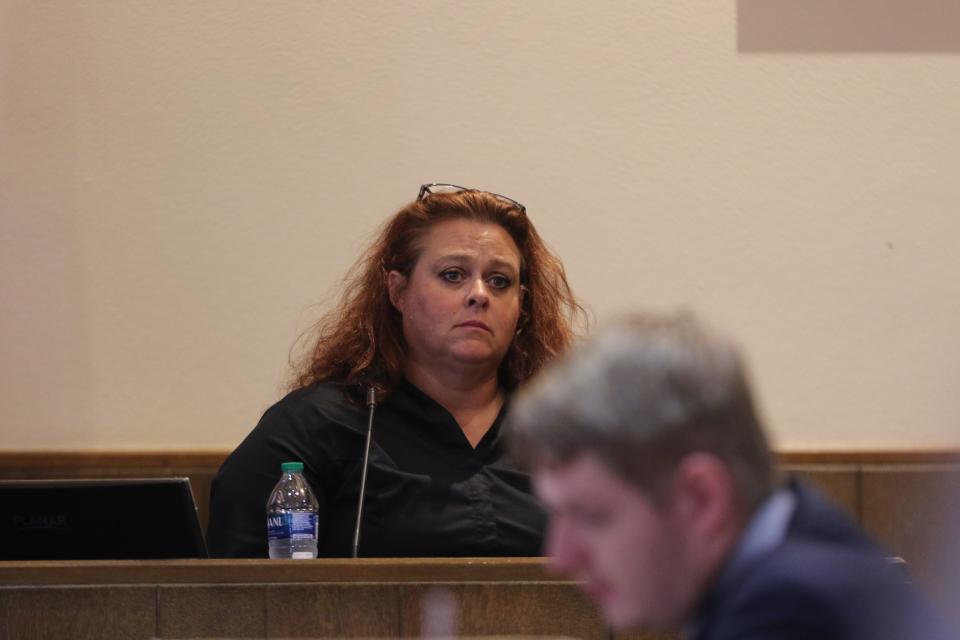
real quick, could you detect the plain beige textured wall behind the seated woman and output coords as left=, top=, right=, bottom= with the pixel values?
left=0, top=0, right=960, bottom=449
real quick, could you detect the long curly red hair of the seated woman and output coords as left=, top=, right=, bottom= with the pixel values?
left=291, top=190, right=586, bottom=395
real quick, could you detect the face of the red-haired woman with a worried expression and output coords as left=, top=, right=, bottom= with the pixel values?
left=389, top=220, right=520, bottom=375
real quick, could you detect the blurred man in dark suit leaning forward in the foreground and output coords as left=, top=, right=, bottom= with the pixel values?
left=511, top=316, right=947, bottom=640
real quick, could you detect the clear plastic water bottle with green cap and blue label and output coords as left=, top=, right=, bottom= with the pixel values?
left=267, top=462, right=318, bottom=560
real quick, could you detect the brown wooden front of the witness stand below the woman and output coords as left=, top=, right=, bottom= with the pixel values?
left=0, top=558, right=608, bottom=638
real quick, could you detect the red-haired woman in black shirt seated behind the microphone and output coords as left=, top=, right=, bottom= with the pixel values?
left=207, top=184, right=583, bottom=557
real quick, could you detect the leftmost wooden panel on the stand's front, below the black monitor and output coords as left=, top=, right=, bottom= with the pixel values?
left=0, top=583, right=157, bottom=640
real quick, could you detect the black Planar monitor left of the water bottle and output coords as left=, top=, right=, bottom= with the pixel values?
left=0, top=478, right=207, bottom=560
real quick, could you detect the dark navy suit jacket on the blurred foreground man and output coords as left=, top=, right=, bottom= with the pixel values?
left=693, top=482, right=949, bottom=640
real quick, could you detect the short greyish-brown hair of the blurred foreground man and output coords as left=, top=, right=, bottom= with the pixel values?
left=508, top=313, right=775, bottom=513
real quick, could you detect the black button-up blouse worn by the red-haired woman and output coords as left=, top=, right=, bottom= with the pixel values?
left=207, top=383, right=545, bottom=557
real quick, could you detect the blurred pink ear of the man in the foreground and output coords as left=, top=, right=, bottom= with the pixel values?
left=672, top=453, right=738, bottom=538
